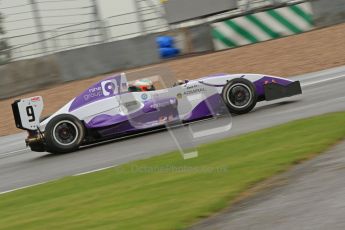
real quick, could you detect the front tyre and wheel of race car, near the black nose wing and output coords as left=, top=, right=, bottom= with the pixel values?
left=222, top=78, right=257, bottom=114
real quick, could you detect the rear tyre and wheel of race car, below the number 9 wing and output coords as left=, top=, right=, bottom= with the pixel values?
left=44, top=114, right=85, bottom=153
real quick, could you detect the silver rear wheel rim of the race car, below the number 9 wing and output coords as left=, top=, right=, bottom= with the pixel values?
left=53, top=120, right=79, bottom=145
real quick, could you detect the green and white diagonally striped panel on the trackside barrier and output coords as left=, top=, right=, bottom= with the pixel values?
left=211, top=2, right=314, bottom=50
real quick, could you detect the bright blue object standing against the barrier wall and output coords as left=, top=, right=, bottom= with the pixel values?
left=156, top=36, right=180, bottom=58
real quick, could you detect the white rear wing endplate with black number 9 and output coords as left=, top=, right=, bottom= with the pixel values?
left=12, top=96, right=43, bottom=130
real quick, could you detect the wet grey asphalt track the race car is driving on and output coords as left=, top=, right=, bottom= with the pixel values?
left=0, top=66, right=345, bottom=194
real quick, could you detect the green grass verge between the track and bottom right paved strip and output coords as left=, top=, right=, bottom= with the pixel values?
left=0, top=112, right=345, bottom=230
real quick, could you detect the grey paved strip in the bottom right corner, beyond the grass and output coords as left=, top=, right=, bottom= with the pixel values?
left=190, top=142, right=345, bottom=230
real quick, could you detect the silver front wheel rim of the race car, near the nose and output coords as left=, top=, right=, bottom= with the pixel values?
left=228, top=83, right=253, bottom=109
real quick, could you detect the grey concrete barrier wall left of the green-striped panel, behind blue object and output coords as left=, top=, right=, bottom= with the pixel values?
left=0, top=25, right=213, bottom=99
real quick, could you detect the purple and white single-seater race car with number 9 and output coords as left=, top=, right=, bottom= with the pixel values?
left=12, top=73, right=302, bottom=153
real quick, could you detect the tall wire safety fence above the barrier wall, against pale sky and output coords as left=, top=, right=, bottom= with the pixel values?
left=0, top=0, right=302, bottom=62
